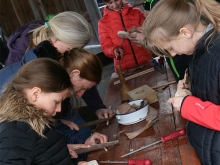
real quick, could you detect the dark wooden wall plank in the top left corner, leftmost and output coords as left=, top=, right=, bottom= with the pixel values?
left=0, top=0, right=20, bottom=38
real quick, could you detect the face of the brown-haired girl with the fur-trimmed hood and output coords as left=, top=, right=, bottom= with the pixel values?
left=33, top=89, right=70, bottom=116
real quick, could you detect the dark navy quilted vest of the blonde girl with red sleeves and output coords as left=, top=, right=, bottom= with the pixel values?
left=187, top=30, right=220, bottom=165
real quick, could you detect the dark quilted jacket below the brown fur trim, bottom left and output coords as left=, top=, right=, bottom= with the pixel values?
left=0, top=121, right=72, bottom=165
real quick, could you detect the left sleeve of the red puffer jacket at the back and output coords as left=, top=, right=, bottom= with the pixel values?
left=98, top=21, right=116, bottom=58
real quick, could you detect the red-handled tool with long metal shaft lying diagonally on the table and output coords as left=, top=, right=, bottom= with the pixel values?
left=121, top=128, right=186, bottom=158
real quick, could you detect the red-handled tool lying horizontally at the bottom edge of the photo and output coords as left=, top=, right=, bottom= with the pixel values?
left=100, top=159, right=151, bottom=165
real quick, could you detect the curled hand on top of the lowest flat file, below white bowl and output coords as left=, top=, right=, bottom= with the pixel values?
left=85, top=132, right=108, bottom=145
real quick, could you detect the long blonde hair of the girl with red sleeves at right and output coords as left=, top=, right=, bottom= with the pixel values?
left=143, top=0, right=220, bottom=55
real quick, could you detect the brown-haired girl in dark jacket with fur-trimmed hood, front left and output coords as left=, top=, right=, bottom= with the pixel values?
left=0, top=58, right=72, bottom=165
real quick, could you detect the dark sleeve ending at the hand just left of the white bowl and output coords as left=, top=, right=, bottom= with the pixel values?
left=82, top=86, right=106, bottom=112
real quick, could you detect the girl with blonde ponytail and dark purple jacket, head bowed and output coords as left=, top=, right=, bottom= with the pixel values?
left=5, top=11, right=93, bottom=65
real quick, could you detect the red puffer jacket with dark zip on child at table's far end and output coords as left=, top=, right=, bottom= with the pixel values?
left=98, top=2, right=152, bottom=70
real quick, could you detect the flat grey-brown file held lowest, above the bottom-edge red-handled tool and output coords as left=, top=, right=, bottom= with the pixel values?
left=75, top=140, right=119, bottom=154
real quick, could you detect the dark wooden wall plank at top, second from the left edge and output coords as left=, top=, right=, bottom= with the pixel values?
left=10, top=0, right=35, bottom=26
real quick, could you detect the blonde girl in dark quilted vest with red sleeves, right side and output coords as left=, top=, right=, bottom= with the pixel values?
left=143, top=0, right=220, bottom=165
